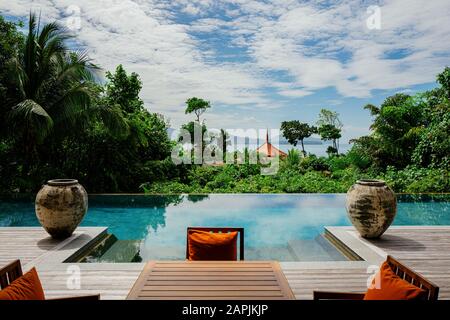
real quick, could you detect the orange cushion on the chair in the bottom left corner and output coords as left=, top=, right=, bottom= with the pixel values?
left=0, top=268, right=45, bottom=300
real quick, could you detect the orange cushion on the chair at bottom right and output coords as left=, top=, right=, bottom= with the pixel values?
left=364, top=262, right=426, bottom=300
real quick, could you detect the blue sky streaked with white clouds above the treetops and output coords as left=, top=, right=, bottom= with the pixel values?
left=0, top=0, right=450, bottom=142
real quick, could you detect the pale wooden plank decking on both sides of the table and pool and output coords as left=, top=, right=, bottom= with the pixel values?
left=0, top=226, right=450, bottom=299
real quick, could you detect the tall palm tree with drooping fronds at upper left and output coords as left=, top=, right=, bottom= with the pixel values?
left=10, top=14, right=98, bottom=155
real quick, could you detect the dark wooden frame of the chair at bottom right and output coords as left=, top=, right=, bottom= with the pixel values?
left=313, top=255, right=439, bottom=301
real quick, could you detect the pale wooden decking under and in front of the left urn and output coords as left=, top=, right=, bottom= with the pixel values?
left=0, top=227, right=144, bottom=299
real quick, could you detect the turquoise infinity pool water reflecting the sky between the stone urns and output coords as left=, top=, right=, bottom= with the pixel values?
left=0, top=194, right=450, bottom=262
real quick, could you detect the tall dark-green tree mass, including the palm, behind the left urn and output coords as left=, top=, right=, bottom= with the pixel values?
left=0, top=15, right=171, bottom=192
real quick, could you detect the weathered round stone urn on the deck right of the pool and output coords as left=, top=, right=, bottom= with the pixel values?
left=347, top=180, right=397, bottom=238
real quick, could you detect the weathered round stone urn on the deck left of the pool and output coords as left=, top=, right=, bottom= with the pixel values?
left=35, top=179, right=88, bottom=239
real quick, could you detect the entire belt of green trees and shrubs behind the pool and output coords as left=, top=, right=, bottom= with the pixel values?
left=0, top=16, right=450, bottom=193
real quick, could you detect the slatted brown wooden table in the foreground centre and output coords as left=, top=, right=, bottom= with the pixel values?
left=127, top=261, right=295, bottom=300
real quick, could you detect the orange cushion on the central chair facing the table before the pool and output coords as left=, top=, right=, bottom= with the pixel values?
left=188, top=230, right=237, bottom=260
